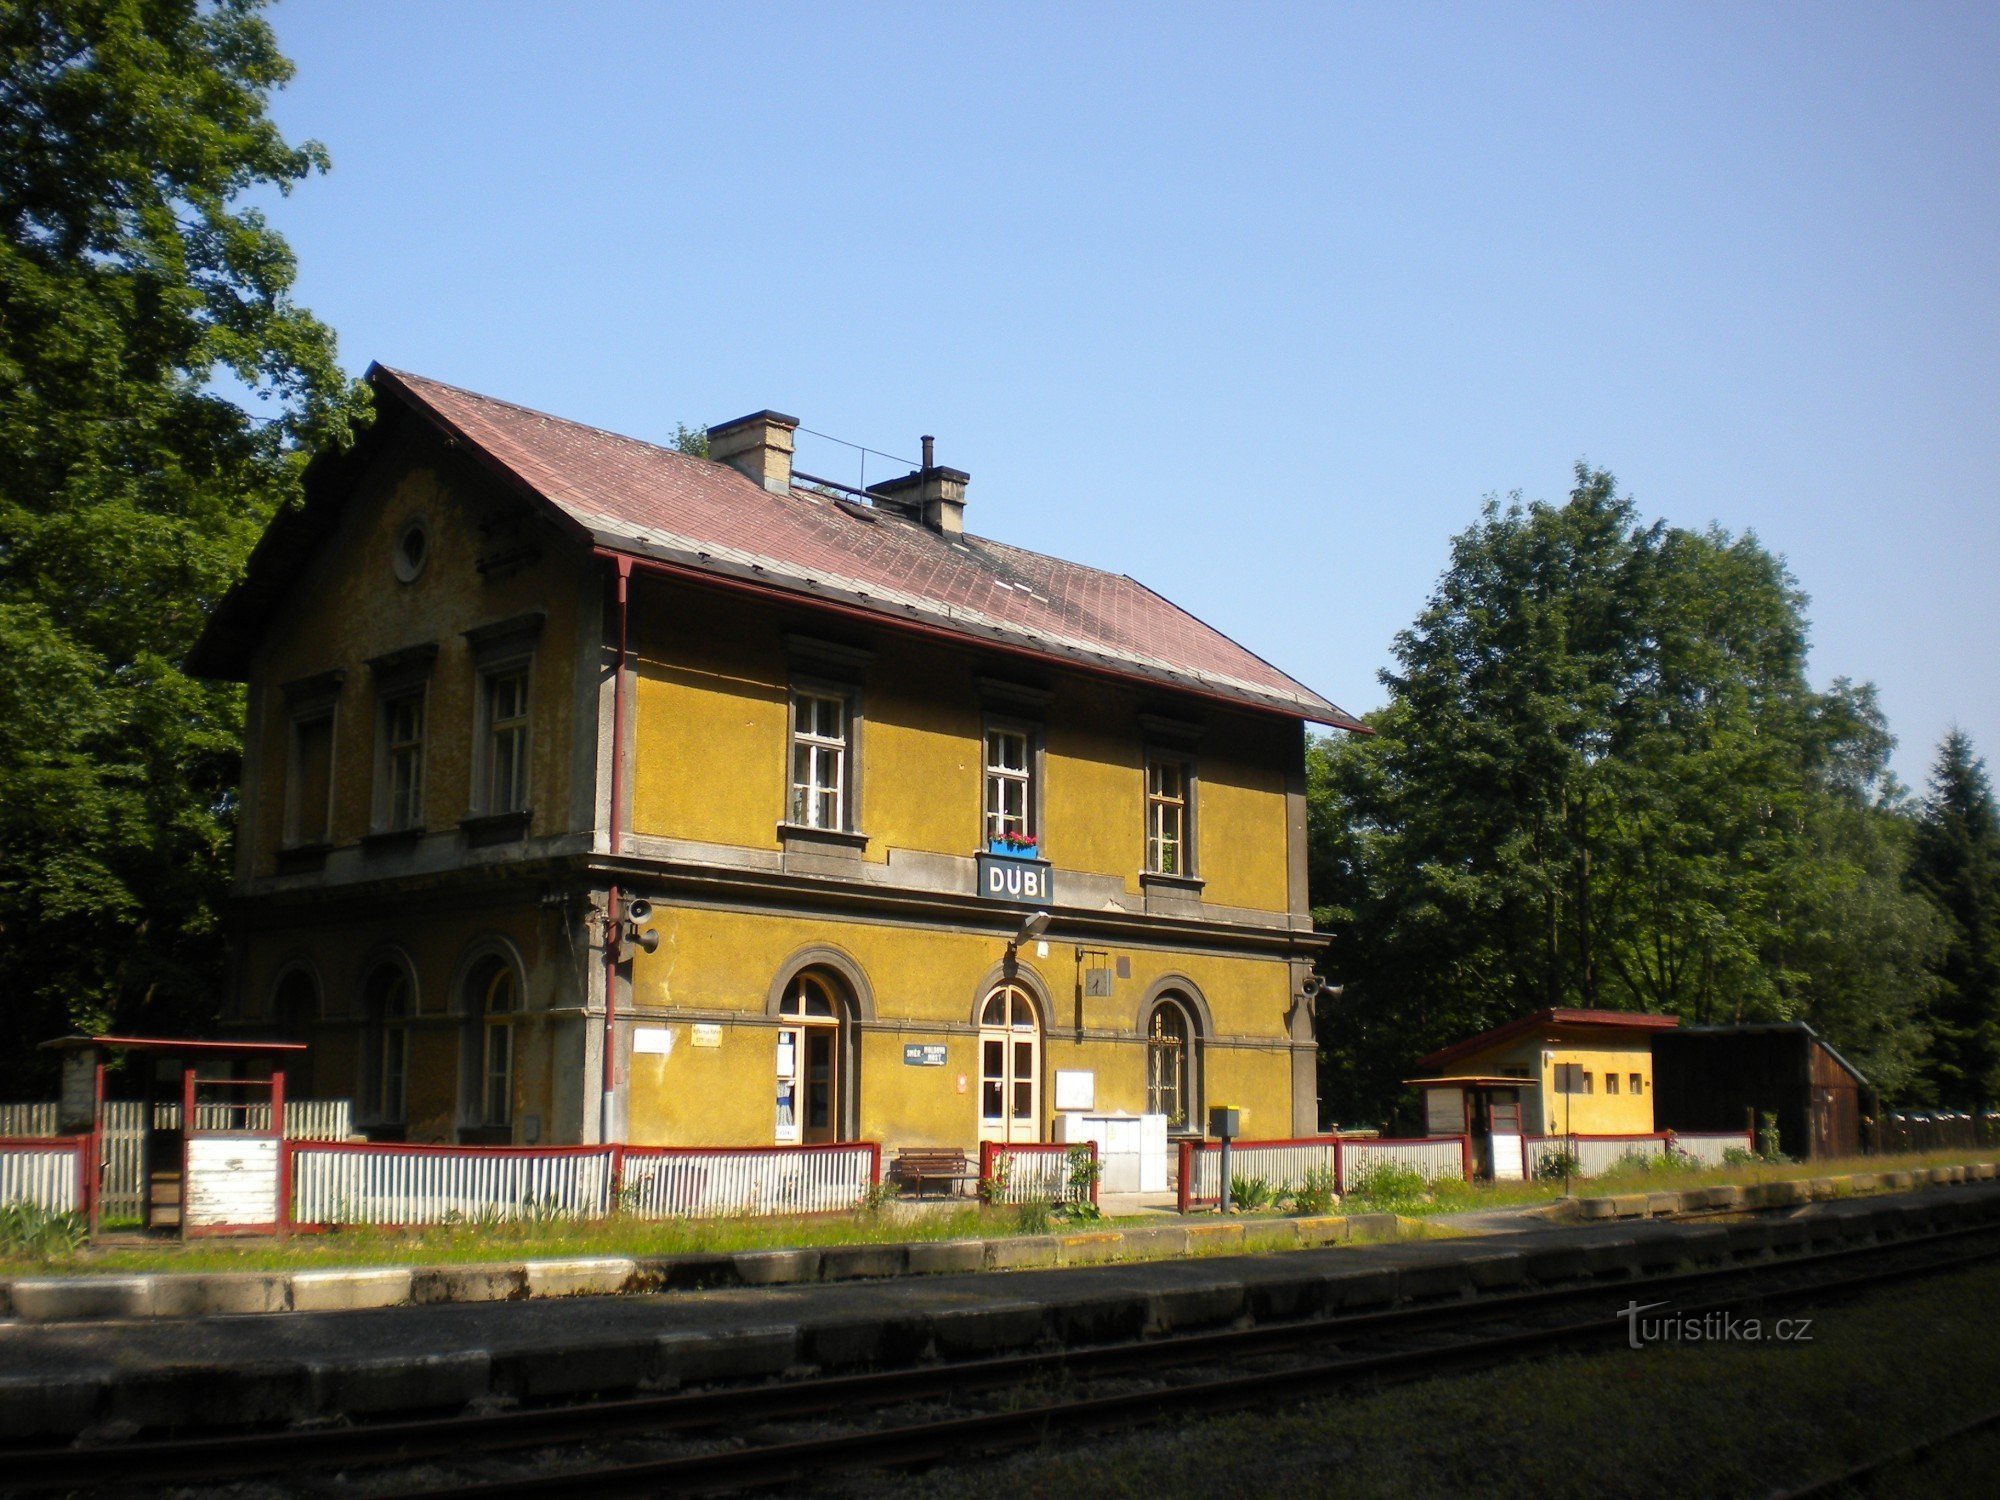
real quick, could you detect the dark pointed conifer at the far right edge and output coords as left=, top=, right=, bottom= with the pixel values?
left=1910, top=730, right=2000, bottom=1108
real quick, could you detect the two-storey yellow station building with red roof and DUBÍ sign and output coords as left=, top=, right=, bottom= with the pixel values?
left=190, top=366, right=1360, bottom=1146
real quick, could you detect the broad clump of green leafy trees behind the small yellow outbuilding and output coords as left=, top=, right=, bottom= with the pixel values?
left=1310, top=466, right=1938, bottom=1118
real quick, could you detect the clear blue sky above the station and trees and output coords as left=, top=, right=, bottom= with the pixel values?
left=258, top=0, right=2000, bottom=782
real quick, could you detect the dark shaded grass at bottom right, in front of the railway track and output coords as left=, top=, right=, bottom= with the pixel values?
left=864, top=1268, right=2000, bottom=1500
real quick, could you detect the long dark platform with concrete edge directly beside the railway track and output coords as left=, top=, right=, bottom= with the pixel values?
left=0, top=1184, right=2000, bottom=1442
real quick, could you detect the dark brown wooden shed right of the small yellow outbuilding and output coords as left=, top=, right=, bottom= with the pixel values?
left=1652, top=1020, right=1872, bottom=1160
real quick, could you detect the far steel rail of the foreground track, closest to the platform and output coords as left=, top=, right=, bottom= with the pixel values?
left=15, top=1224, right=2000, bottom=1492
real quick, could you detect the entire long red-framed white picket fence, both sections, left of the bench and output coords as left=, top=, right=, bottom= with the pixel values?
left=288, top=1142, right=880, bottom=1226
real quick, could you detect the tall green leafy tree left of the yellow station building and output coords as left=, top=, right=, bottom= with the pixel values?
left=0, top=0, right=364, bottom=1090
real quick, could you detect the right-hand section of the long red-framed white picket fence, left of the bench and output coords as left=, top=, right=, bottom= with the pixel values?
left=618, top=1146, right=876, bottom=1218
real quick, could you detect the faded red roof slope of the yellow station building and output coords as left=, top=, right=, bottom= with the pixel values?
left=368, top=366, right=1362, bottom=728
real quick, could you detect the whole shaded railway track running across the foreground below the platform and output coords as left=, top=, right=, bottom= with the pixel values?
left=15, top=1224, right=2000, bottom=1500
